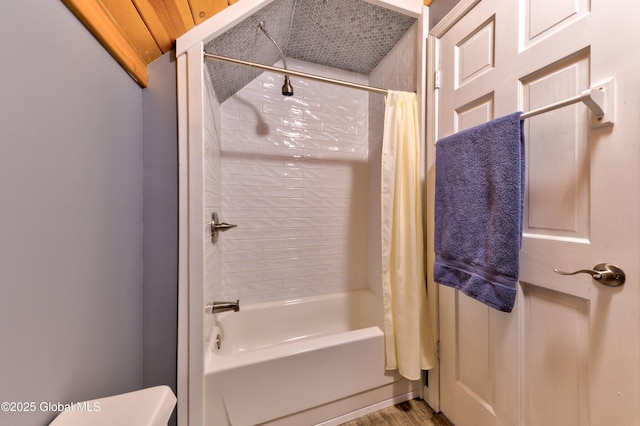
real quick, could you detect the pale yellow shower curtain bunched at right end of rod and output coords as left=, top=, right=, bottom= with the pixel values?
left=381, top=90, right=435, bottom=380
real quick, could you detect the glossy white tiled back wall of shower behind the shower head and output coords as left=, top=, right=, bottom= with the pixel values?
left=216, top=60, right=370, bottom=303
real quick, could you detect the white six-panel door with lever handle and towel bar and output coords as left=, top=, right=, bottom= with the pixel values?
left=428, top=0, right=640, bottom=426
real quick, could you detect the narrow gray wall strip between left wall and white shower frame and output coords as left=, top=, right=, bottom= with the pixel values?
left=142, top=53, right=178, bottom=424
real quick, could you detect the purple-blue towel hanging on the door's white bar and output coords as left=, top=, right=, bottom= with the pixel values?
left=434, top=112, right=525, bottom=312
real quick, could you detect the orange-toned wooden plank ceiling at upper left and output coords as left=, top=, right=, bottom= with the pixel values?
left=63, top=0, right=432, bottom=87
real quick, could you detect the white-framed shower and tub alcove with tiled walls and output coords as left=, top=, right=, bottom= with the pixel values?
left=176, top=0, right=428, bottom=426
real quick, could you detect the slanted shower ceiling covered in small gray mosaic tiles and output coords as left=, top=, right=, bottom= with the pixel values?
left=204, top=0, right=416, bottom=103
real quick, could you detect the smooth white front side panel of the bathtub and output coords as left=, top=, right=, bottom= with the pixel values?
left=205, top=327, right=396, bottom=426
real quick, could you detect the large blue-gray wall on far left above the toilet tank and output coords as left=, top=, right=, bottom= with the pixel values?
left=0, top=0, right=146, bottom=425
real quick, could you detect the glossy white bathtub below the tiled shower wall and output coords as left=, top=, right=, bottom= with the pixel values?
left=204, top=290, right=419, bottom=426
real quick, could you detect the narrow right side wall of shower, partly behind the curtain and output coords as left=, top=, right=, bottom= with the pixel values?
left=369, top=24, right=418, bottom=295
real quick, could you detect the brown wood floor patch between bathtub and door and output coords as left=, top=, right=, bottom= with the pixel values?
left=340, top=399, right=453, bottom=426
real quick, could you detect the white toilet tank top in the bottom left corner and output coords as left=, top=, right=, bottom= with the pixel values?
left=50, top=386, right=176, bottom=426
